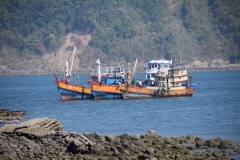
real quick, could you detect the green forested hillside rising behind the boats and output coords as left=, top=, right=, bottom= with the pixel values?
left=0, top=0, right=240, bottom=75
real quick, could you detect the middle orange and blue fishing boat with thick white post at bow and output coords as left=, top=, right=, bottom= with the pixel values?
left=89, top=59, right=125, bottom=99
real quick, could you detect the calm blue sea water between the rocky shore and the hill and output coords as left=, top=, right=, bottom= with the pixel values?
left=0, top=71, right=240, bottom=142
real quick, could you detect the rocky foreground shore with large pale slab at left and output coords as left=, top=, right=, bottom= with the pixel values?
left=0, top=118, right=240, bottom=160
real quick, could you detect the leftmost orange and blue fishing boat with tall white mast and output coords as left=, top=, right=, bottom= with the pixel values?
left=55, top=46, right=93, bottom=100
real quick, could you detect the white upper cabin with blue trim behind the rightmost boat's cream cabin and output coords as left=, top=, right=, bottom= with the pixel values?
left=145, top=59, right=172, bottom=86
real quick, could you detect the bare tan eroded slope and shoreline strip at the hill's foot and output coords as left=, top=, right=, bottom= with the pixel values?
left=0, top=33, right=240, bottom=76
